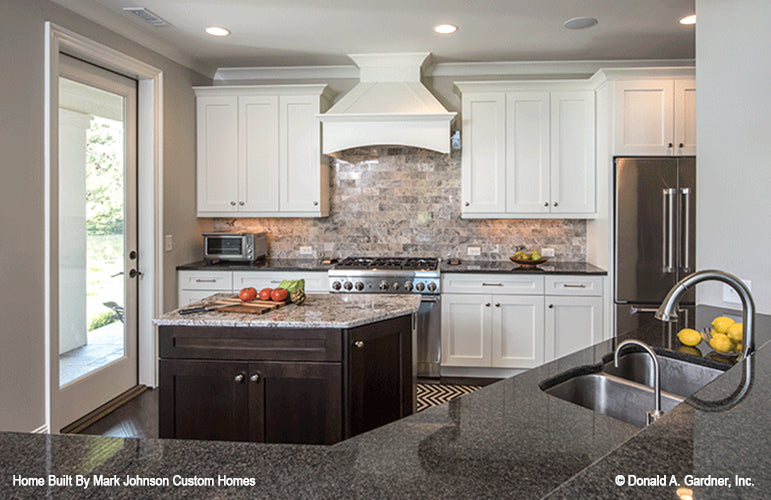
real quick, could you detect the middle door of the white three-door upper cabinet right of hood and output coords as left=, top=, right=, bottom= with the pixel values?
left=506, top=92, right=549, bottom=213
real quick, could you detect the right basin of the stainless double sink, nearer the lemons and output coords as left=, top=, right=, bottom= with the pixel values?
left=602, top=352, right=723, bottom=397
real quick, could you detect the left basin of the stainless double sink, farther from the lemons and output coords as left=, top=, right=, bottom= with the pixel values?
left=544, top=374, right=684, bottom=427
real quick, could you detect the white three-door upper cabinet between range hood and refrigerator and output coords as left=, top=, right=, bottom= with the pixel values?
left=455, top=82, right=596, bottom=219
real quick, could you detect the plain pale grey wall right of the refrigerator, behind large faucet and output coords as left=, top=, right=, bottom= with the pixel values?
left=696, top=0, right=771, bottom=313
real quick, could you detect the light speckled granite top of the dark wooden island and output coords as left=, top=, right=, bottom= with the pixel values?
left=154, top=293, right=420, bottom=328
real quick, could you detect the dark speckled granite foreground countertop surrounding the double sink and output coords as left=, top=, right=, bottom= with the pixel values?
left=0, top=310, right=771, bottom=499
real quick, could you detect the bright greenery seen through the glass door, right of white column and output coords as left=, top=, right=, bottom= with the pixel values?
left=86, top=117, right=124, bottom=331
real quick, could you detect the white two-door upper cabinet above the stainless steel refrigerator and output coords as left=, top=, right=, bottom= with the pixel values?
left=613, top=78, right=696, bottom=156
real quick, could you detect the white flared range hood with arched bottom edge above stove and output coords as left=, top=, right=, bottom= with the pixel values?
left=318, top=52, right=456, bottom=154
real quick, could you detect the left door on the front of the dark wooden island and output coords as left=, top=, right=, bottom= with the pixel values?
left=158, top=359, right=249, bottom=441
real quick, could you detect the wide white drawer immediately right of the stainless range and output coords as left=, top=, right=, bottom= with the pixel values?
left=442, top=273, right=543, bottom=295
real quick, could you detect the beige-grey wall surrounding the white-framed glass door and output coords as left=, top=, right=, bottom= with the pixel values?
left=0, top=0, right=211, bottom=431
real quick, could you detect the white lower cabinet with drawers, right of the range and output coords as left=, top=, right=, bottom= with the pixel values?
left=442, top=273, right=604, bottom=369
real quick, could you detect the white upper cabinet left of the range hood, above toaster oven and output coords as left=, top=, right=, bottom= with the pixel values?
left=195, top=85, right=330, bottom=217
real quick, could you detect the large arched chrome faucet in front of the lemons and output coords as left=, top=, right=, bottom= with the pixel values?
left=656, top=270, right=755, bottom=358
